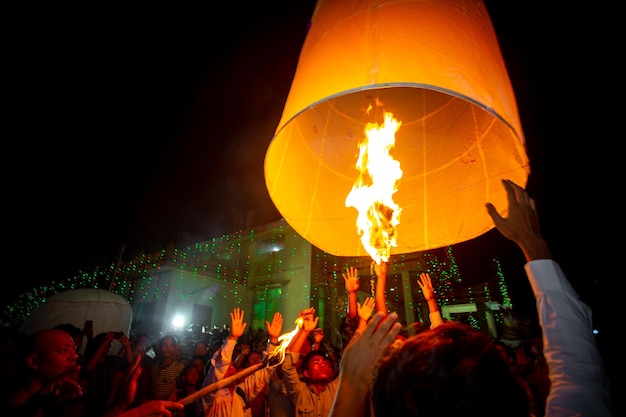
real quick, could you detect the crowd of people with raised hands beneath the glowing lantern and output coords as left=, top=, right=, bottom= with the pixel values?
left=0, top=180, right=612, bottom=417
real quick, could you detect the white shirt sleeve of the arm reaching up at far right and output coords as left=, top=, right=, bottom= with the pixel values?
left=524, top=259, right=612, bottom=417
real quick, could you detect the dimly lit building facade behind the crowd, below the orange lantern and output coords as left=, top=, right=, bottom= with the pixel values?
left=124, top=220, right=508, bottom=345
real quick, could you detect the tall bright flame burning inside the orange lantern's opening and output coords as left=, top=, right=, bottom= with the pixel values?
left=345, top=108, right=402, bottom=265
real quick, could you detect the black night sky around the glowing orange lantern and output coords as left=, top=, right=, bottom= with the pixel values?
left=2, top=0, right=622, bottom=334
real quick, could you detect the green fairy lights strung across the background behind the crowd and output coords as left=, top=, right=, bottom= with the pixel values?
left=0, top=221, right=512, bottom=327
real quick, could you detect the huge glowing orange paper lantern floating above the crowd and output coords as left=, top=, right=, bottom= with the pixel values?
left=265, top=0, right=530, bottom=256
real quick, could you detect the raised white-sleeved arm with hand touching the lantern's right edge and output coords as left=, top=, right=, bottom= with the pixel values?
left=486, top=180, right=612, bottom=417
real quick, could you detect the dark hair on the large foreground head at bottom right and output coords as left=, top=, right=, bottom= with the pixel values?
left=371, top=321, right=530, bottom=417
